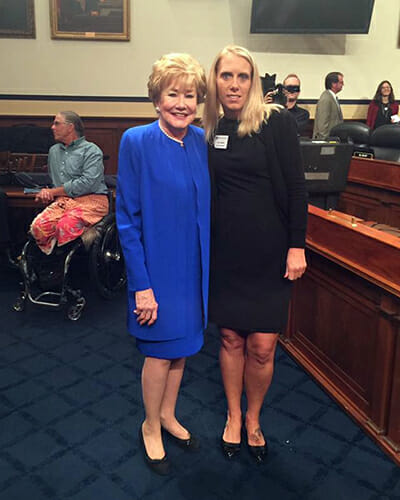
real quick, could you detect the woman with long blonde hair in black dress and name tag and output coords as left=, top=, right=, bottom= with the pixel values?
left=203, top=46, right=307, bottom=462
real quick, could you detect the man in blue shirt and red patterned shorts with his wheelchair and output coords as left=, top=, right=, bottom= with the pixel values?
left=14, top=111, right=125, bottom=319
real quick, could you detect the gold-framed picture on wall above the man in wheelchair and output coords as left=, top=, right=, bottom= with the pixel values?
left=49, top=0, right=130, bottom=41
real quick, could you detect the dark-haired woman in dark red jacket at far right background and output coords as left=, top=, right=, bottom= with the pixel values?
left=367, top=80, right=399, bottom=130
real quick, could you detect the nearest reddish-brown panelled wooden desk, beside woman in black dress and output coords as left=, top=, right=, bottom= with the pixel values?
left=282, top=206, right=400, bottom=465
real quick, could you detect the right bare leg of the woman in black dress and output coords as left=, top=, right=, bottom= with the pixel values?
left=244, top=333, right=278, bottom=446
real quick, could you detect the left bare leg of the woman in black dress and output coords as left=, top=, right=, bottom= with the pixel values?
left=219, top=328, right=245, bottom=443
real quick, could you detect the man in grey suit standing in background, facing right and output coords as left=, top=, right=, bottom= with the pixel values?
left=313, top=71, right=344, bottom=140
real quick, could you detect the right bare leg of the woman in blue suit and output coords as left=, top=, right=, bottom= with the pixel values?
left=161, top=358, right=190, bottom=439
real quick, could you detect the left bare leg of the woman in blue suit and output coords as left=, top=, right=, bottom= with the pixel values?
left=142, top=357, right=171, bottom=459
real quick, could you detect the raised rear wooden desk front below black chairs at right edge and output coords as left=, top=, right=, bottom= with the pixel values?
left=339, top=158, right=400, bottom=227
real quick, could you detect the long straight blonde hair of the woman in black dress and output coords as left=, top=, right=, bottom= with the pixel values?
left=202, top=45, right=281, bottom=142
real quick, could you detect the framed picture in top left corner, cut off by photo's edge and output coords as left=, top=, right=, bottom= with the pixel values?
left=0, top=0, right=36, bottom=38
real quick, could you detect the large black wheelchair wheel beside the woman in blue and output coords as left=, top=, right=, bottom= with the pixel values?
left=89, top=214, right=126, bottom=299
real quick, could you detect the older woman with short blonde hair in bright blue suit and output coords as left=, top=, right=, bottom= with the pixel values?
left=117, top=54, right=210, bottom=474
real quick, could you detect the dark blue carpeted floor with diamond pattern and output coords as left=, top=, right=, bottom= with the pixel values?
left=0, top=268, right=400, bottom=500
